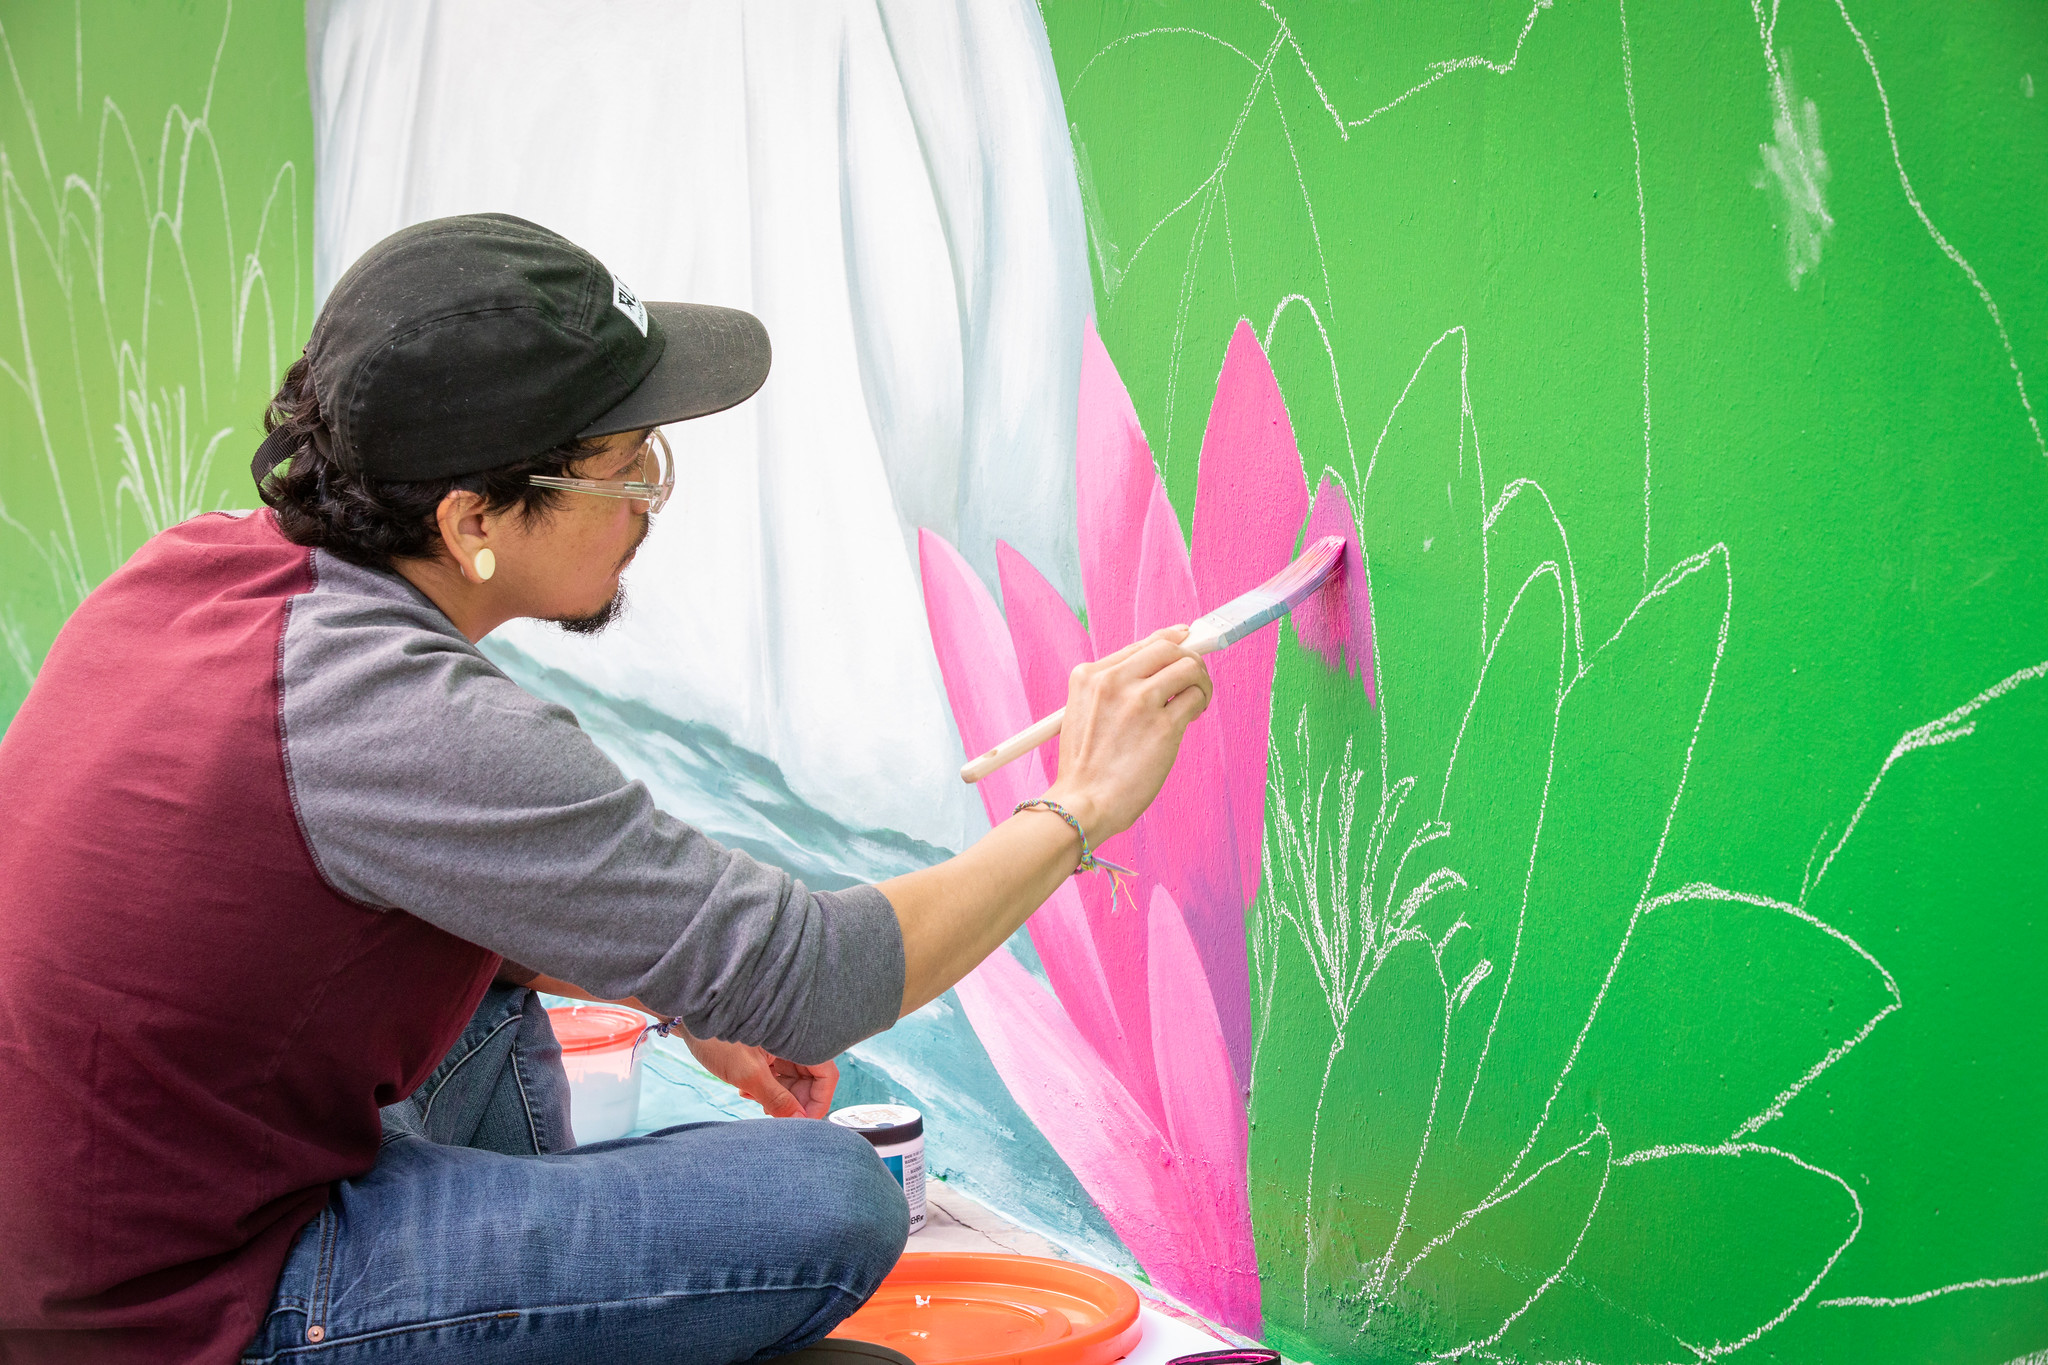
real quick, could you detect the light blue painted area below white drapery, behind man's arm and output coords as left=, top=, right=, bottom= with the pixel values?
left=501, top=641, right=1137, bottom=1273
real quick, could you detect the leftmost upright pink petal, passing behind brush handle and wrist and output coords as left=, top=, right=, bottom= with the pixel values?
left=918, top=530, right=1151, bottom=1085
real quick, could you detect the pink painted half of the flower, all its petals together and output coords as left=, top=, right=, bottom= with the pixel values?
left=920, top=315, right=1370, bottom=1332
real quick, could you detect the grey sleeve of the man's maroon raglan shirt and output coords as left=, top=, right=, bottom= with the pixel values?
left=279, top=553, right=903, bottom=1062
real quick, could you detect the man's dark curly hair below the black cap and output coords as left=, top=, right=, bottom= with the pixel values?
left=256, top=356, right=600, bottom=569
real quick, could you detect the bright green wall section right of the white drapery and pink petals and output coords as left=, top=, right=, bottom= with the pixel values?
left=1042, top=0, right=2048, bottom=1363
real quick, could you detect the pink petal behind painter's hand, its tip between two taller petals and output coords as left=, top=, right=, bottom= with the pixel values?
left=1124, top=487, right=1251, bottom=1083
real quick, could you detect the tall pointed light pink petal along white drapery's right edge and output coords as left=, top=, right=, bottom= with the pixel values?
left=1073, top=321, right=1159, bottom=659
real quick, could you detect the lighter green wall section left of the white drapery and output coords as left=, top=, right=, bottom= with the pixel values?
left=0, top=0, right=313, bottom=722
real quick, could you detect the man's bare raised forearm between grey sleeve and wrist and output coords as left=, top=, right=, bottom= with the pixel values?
left=877, top=792, right=1092, bottom=1015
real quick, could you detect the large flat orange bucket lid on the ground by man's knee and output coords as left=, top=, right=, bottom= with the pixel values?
left=831, top=1252, right=1143, bottom=1365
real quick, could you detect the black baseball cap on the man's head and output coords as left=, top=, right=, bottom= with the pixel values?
left=250, top=213, right=770, bottom=483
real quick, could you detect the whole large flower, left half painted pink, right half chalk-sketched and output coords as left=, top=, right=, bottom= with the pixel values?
left=924, top=313, right=2048, bottom=1361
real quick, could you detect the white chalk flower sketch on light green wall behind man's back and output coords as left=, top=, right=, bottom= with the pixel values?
left=0, top=4, right=305, bottom=700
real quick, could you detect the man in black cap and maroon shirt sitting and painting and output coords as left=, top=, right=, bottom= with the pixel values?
left=0, top=215, right=1208, bottom=1363
